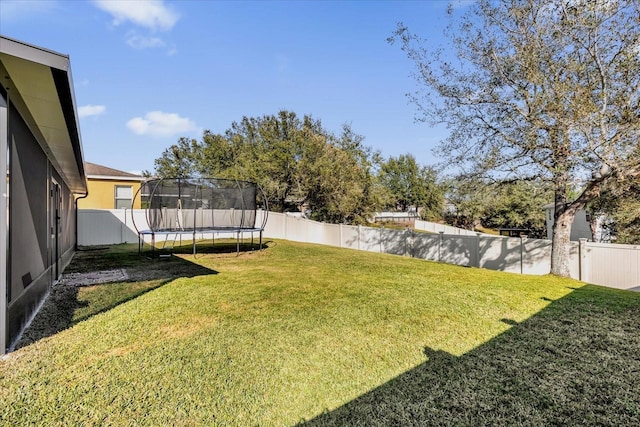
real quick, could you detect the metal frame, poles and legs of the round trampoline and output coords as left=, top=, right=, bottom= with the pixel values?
left=131, top=178, right=269, bottom=257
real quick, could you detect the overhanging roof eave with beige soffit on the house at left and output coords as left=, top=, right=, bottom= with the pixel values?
left=0, top=36, right=87, bottom=194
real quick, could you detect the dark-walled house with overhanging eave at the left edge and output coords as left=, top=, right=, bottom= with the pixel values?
left=0, top=36, right=86, bottom=353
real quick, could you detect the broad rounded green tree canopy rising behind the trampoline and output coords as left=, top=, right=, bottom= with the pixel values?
left=155, top=110, right=384, bottom=223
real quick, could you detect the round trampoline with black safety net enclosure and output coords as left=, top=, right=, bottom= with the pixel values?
left=132, top=178, right=269, bottom=255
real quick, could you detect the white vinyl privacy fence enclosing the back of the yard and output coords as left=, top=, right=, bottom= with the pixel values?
left=78, top=209, right=640, bottom=290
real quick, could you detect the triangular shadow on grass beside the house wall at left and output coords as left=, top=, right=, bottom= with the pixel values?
left=16, top=245, right=228, bottom=349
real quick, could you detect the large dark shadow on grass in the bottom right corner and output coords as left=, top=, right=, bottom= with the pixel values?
left=303, top=285, right=640, bottom=426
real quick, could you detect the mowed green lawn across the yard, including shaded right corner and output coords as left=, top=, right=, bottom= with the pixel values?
left=0, top=241, right=640, bottom=426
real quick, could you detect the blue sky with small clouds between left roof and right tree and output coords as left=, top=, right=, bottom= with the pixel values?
left=0, top=0, right=464, bottom=172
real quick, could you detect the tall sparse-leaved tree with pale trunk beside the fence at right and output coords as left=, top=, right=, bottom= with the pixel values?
left=390, top=0, right=640, bottom=276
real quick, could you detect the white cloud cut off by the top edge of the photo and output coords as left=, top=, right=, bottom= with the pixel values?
left=93, top=0, right=180, bottom=31
